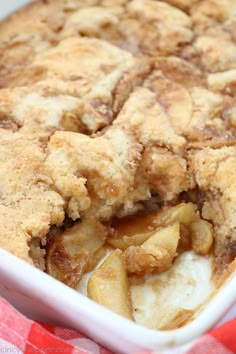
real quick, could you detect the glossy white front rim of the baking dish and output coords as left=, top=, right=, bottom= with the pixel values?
left=0, top=249, right=236, bottom=349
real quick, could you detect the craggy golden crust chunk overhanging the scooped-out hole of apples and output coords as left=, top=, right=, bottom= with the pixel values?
left=47, top=88, right=189, bottom=224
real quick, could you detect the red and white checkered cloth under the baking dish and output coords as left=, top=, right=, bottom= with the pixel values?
left=0, top=297, right=236, bottom=354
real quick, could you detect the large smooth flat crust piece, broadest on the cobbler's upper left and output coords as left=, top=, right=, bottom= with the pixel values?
left=0, top=38, right=150, bottom=131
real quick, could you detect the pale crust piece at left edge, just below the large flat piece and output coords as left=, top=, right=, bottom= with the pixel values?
left=0, top=87, right=86, bottom=141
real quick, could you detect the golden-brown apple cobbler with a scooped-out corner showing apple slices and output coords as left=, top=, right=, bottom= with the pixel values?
left=0, top=0, right=236, bottom=328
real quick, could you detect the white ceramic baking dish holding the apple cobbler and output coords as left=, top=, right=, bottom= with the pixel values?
left=0, top=0, right=236, bottom=354
